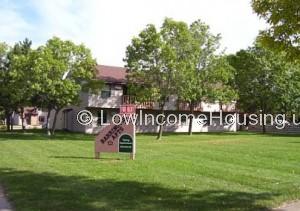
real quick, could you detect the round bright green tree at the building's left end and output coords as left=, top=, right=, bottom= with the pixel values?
left=34, top=37, right=102, bottom=134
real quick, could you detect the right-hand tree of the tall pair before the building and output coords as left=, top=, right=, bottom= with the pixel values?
left=177, top=20, right=235, bottom=135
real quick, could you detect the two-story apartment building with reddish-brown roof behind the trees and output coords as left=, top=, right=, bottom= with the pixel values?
left=50, top=65, right=237, bottom=134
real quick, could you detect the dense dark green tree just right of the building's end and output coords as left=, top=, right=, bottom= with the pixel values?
left=228, top=45, right=289, bottom=132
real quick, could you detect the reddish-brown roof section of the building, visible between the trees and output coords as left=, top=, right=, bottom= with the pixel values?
left=96, top=65, right=127, bottom=84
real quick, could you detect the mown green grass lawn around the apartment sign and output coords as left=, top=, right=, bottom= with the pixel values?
left=0, top=132, right=300, bottom=211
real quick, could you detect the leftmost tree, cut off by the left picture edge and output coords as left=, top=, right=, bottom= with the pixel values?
left=0, top=39, right=35, bottom=130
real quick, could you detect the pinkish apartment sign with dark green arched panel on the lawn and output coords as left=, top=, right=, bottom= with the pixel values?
left=95, top=105, right=136, bottom=160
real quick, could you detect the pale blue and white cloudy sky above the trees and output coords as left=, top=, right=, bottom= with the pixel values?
left=0, top=0, right=266, bottom=66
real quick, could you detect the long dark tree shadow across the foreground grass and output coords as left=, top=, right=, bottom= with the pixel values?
left=0, top=169, right=273, bottom=211
